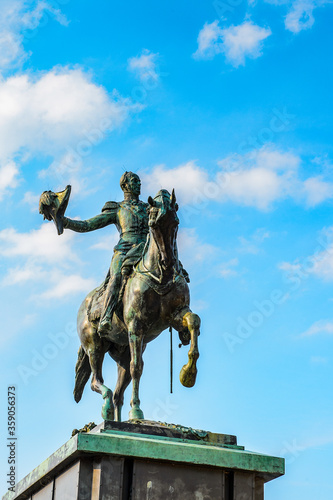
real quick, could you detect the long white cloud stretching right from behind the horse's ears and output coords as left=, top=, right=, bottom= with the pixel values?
left=142, top=148, right=299, bottom=210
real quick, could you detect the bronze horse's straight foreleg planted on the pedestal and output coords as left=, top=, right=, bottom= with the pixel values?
left=128, top=325, right=144, bottom=420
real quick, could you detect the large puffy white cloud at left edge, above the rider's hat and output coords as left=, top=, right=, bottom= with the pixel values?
left=0, top=67, right=140, bottom=194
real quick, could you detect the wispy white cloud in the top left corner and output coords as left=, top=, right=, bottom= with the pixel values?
left=0, top=0, right=68, bottom=71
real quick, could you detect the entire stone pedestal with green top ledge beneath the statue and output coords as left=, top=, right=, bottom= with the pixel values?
left=3, top=421, right=284, bottom=500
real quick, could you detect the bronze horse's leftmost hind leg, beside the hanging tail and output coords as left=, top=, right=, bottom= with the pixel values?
left=87, top=331, right=114, bottom=420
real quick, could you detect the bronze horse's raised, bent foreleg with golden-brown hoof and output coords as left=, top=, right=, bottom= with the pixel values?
left=179, top=311, right=200, bottom=387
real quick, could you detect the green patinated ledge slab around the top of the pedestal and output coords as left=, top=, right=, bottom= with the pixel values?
left=3, top=430, right=284, bottom=500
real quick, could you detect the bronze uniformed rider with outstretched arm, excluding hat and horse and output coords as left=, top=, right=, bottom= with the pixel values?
left=63, top=172, right=148, bottom=335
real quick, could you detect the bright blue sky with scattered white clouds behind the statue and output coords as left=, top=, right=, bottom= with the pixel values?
left=0, top=0, right=333, bottom=500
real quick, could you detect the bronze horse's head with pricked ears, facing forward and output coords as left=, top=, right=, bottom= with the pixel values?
left=148, top=189, right=179, bottom=269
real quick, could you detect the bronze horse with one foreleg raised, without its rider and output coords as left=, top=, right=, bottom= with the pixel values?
left=74, top=189, right=200, bottom=421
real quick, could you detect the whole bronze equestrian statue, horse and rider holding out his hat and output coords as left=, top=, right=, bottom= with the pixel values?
left=40, top=172, right=200, bottom=421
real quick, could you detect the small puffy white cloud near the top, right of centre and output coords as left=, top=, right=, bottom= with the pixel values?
left=193, top=20, right=272, bottom=67
